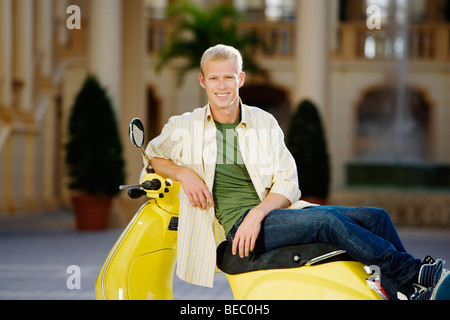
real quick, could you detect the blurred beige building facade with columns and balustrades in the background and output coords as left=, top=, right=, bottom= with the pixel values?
left=0, top=0, right=450, bottom=223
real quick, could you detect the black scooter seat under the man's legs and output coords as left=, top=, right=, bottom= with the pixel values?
left=217, top=241, right=353, bottom=275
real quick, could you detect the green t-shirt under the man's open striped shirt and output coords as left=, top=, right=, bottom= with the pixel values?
left=213, top=120, right=261, bottom=235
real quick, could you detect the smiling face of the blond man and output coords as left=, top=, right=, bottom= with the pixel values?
left=199, top=58, right=245, bottom=123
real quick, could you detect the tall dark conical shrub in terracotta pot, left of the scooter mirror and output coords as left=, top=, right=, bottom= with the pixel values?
left=65, top=76, right=125, bottom=230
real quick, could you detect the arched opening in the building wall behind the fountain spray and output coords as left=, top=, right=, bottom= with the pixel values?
left=355, top=87, right=431, bottom=161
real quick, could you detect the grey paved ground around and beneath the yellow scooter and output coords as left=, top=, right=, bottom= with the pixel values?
left=0, top=212, right=450, bottom=300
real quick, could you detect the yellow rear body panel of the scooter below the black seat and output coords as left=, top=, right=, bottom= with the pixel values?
left=227, top=261, right=382, bottom=300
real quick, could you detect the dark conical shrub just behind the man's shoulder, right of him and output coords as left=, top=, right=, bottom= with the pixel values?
left=286, top=100, right=330, bottom=204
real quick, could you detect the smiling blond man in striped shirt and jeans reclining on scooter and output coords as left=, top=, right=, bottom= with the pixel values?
left=146, top=45, right=450, bottom=299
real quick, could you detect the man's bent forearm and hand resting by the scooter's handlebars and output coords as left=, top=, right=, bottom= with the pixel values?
left=150, top=158, right=214, bottom=209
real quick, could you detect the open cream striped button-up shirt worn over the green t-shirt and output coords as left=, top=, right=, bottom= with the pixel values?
left=146, top=104, right=310, bottom=287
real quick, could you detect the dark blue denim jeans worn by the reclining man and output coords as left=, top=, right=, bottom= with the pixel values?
left=229, top=206, right=422, bottom=299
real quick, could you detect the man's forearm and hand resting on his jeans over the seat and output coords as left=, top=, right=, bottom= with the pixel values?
left=232, top=193, right=291, bottom=258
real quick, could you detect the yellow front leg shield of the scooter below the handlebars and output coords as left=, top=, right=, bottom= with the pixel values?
left=95, top=200, right=177, bottom=300
